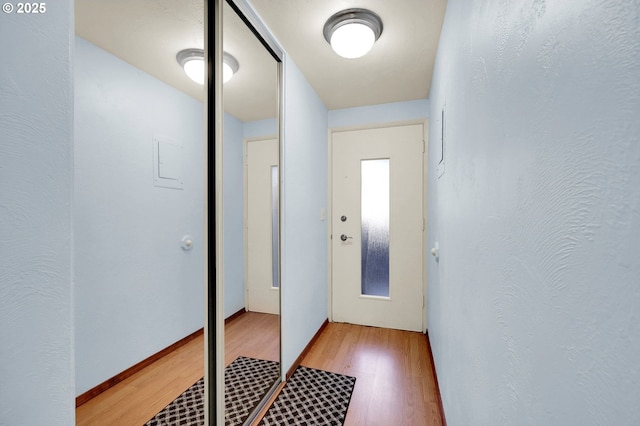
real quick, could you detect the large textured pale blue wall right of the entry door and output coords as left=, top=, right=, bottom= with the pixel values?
left=428, top=0, right=640, bottom=426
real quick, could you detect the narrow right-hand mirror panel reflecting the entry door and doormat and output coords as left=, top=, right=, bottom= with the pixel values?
left=222, top=1, right=281, bottom=422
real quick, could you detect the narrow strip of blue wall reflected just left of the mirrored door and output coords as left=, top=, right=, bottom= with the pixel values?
left=222, top=113, right=245, bottom=318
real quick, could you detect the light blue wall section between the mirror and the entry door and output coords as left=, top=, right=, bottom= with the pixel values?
left=281, top=58, right=328, bottom=372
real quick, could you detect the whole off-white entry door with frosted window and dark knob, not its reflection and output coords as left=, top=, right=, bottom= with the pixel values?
left=332, top=124, right=424, bottom=331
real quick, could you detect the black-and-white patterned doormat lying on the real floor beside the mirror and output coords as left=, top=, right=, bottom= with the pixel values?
left=259, top=366, right=356, bottom=426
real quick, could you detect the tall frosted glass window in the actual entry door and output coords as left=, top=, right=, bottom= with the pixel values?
left=360, top=158, right=389, bottom=297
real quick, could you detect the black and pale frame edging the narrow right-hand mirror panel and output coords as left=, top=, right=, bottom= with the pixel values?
left=204, top=0, right=285, bottom=425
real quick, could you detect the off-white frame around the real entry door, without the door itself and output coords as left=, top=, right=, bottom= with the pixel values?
left=327, top=119, right=429, bottom=332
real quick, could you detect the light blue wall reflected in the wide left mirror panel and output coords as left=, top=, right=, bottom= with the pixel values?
left=73, top=38, right=204, bottom=394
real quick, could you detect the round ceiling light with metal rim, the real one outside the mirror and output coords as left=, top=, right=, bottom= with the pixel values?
left=322, top=8, right=382, bottom=58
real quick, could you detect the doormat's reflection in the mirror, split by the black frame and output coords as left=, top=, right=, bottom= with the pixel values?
left=145, top=356, right=280, bottom=426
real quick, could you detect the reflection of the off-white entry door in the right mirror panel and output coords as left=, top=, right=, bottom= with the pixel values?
left=245, top=139, right=280, bottom=314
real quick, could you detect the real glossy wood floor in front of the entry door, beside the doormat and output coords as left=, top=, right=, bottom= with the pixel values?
left=301, top=323, right=442, bottom=426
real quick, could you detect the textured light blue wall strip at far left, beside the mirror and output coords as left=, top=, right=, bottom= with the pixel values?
left=0, top=0, right=75, bottom=425
